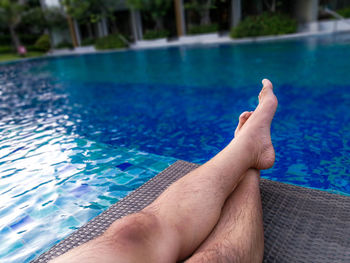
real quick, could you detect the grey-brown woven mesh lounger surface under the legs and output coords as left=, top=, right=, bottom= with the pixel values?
left=32, top=161, right=350, bottom=263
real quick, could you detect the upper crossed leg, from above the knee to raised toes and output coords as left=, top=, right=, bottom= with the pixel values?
left=50, top=80, right=277, bottom=262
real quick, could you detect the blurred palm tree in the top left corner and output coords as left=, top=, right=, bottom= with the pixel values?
left=0, top=0, right=25, bottom=50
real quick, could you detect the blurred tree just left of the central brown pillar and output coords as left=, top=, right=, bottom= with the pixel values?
left=128, top=0, right=172, bottom=30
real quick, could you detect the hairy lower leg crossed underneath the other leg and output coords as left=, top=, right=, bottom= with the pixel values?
left=187, top=169, right=264, bottom=263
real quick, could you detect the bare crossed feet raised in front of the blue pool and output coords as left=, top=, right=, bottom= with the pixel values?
left=235, top=79, right=278, bottom=170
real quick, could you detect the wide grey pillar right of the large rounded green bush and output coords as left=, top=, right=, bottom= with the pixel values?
left=294, top=0, right=319, bottom=23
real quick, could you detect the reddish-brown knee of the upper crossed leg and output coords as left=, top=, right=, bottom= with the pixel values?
left=104, top=211, right=160, bottom=249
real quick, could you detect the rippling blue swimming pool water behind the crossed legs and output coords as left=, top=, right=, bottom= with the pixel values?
left=0, top=35, right=350, bottom=262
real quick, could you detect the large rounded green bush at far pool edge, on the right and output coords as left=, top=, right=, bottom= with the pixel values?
left=230, top=13, right=297, bottom=38
